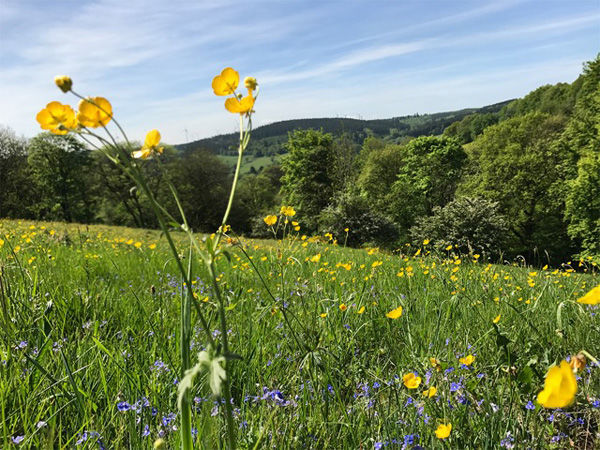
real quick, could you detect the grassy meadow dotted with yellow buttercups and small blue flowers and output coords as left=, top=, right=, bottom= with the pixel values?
left=0, top=220, right=600, bottom=448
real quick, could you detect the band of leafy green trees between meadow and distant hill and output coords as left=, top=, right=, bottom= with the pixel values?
left=0, top=57, right=600, bottom=263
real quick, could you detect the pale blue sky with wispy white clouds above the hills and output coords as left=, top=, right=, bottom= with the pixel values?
left=0, top=0, right=600, bottom=144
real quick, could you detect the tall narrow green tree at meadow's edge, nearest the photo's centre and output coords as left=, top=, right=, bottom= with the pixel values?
left=281, top=130, right=333, bottom=230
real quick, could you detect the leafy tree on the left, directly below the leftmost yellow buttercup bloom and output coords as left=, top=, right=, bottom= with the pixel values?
left=28, top=133, right=93, bottom=223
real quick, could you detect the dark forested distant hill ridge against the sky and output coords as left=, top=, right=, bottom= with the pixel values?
left=177, top=100, right=512, bottom=156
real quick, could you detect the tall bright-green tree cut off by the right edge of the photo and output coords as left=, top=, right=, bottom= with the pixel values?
left=561, top=55, right=600, bottom=257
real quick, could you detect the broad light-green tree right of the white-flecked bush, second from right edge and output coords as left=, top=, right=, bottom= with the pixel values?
left=459, top=113, right=574, bottom=260
